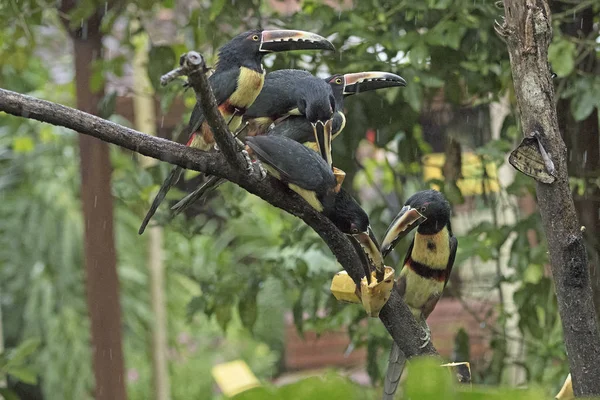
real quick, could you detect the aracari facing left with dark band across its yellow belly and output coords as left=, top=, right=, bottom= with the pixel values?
left=381, top=190, right=458, bottom=400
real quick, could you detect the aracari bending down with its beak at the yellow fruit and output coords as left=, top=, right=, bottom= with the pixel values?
left=246, top=135, right=379, bottom=272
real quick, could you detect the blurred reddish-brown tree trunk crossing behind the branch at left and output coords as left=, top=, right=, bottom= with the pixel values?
left=63, top=7, right=127, bottom=400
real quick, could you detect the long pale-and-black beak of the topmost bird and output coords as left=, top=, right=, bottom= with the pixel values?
left=260, top=29, right=335, bottom=53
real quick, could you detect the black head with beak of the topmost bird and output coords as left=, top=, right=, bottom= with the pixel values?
left=216, top=29, right=335, bottom=71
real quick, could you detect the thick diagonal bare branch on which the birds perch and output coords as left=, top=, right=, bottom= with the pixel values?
left=0, top=84, right=437, bottom=358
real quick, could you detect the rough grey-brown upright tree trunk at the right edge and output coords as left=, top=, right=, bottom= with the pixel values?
left=497, top=0, right=600, bottom=396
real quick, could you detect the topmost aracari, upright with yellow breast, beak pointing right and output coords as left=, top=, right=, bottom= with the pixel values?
left=138, top=29, right=334, bottom=234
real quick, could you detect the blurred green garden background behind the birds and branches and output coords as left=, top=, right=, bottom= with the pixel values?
left=0, top=0, right=600, bottom=400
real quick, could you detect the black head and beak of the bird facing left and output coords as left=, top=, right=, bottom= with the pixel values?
left=381, top=190, right=452, bottom=257
